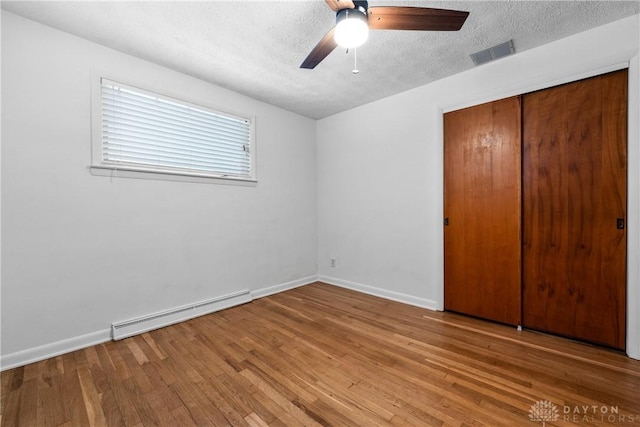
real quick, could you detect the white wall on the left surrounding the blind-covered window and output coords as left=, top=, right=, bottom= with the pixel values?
left=1, top=11, right=317, bottom=368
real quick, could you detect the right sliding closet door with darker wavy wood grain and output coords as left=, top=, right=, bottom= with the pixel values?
left=523, top=70, right=627, bottom=349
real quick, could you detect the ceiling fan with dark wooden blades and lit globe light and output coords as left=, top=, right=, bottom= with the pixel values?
left=300, top=0, right=469, bottom=69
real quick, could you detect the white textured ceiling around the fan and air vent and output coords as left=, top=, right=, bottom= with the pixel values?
left=2, top=0, right=640, bottom=119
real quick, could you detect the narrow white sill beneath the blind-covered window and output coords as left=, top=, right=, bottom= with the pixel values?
left=89, top=165, right=258, bottom=187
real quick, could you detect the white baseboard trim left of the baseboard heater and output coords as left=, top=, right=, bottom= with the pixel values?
left=0, top=329, right=111, bottom=371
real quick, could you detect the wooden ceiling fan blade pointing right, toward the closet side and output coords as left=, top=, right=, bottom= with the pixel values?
left=369, top=6, right=469, bottom=31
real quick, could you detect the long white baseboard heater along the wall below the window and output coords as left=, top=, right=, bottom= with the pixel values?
left=111, top=289, right=253, bottom=341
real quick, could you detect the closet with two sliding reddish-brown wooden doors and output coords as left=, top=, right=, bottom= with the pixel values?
left=444, top=70, right=627, bottom=349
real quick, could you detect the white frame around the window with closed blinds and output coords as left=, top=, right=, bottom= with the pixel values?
left=89, top=70, right=257, bottom=185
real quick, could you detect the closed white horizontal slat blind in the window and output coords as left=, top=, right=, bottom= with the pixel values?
left=101, top=79, right=252, bottom=179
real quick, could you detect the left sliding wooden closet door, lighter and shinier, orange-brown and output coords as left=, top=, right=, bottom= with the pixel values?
left=444, top=97, right=521, bottom=325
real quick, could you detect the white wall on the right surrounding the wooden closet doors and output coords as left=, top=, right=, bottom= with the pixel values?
left=317, top=15, right=640, bottom=358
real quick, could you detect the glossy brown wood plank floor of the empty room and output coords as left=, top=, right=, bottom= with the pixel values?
left=0, top=283, right=640, bottom=426
